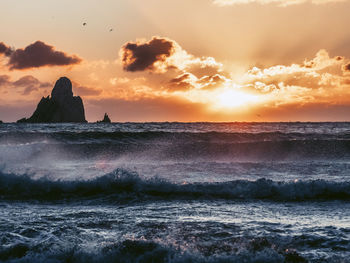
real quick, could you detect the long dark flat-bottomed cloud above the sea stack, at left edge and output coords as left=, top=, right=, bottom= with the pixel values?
left=0, top=41, right=82, bottom=70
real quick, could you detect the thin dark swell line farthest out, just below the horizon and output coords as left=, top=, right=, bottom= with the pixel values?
left=0, top=131, right=350, bottom=143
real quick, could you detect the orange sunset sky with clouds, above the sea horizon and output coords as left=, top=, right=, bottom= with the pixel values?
left=0, top=0, right=350, bottom=122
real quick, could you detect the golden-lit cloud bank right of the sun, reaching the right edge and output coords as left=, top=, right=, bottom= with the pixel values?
left=234, top=50, right=350, bottom=107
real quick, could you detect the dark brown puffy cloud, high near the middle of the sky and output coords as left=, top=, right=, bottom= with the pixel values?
left=121, top=37, right=174, bottom=72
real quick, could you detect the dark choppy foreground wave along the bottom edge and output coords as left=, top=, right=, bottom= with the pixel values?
left=0, top=239, right=308, bottom=263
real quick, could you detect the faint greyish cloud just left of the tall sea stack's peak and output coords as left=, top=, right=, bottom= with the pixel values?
left=0, top=75, right=52, bottom=95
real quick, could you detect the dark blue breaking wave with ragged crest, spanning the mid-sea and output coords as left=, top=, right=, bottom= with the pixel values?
left=0, top=169, right=350, bottom=202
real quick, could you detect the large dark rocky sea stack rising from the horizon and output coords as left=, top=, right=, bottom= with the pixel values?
left=17, top=77, right=86, bottom=123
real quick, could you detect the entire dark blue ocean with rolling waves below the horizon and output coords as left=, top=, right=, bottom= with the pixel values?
left=0, top=123, right=350, bottom=263
